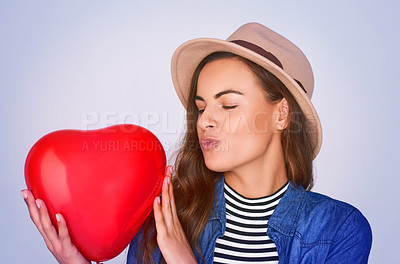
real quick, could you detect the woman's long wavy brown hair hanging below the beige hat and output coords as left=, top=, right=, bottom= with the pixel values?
left=140, top=52, right=315, bottom=263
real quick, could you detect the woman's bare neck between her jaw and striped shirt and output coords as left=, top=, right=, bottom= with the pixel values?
left=224, top=138, right=288, bottom=198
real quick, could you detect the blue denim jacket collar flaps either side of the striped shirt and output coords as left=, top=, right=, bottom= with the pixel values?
left=209, top=174, right=306, bottom=236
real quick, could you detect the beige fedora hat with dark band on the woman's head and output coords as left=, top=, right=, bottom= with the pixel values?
left=171, top=23, right=322, bottom=158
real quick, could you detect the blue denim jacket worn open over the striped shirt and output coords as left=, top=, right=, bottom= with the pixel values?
left=127, top=175, right=372, bottom=264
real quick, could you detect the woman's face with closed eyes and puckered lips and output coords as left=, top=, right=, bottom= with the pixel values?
left=195, top=58, right=283, bottom=172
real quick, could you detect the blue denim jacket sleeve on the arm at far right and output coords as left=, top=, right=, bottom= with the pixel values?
left=325, top=209, right=372, bottom=264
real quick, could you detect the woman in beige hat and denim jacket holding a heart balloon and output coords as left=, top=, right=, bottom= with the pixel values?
left=23, top=23, right=372, bottom=264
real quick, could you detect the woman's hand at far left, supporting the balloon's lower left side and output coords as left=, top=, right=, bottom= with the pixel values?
left=21, top=190, right=91, bottom=264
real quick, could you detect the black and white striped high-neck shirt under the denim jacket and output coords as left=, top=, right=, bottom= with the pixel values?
left=214, top=182, right=289, bottom=264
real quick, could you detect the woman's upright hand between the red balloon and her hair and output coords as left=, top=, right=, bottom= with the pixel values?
left=153, top=166, right=197, bottom=264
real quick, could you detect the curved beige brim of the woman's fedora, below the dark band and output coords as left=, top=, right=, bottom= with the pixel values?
left=171, top=38, right=322, bottom=158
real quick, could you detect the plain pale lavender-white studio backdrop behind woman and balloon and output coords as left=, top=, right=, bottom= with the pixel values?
left=0, top=0, right=400, bottom=264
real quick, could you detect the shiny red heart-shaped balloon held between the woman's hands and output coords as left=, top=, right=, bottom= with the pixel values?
left=25, top=124, right=166, bottom=262
